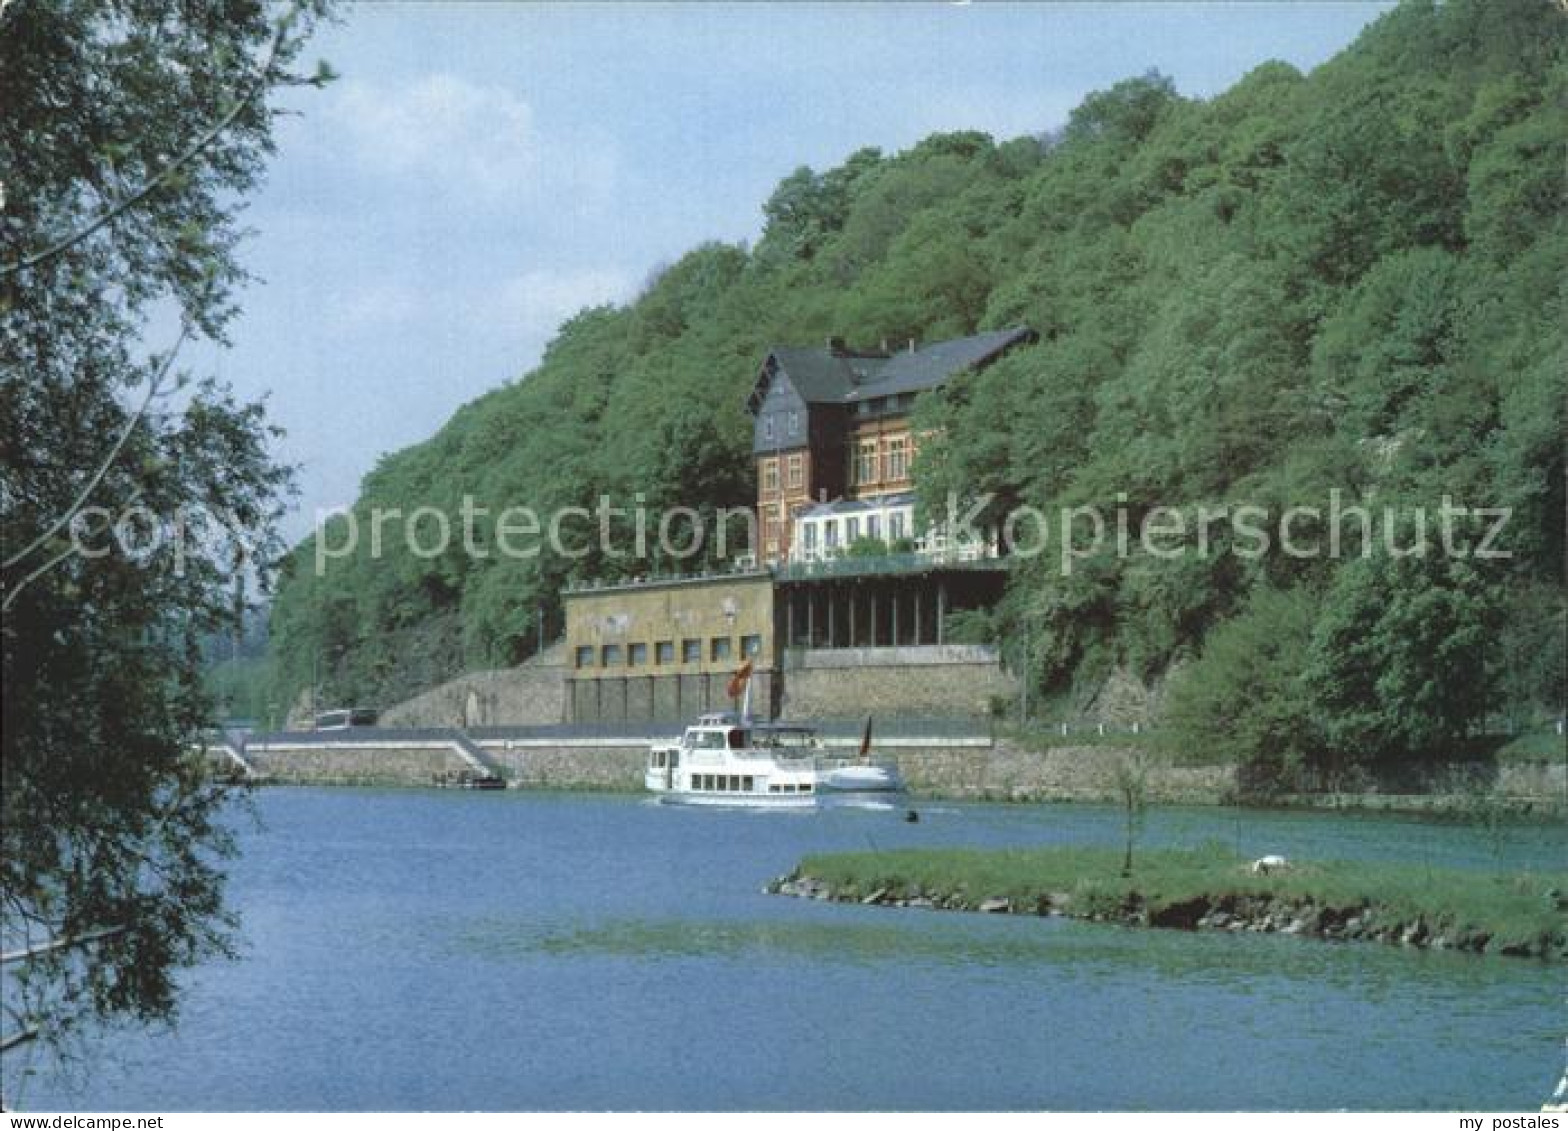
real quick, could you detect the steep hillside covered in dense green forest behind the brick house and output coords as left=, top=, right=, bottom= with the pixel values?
left=271, top=0, right=1568, bottom=784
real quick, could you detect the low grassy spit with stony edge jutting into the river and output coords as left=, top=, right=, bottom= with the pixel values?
left=776, top=847, right=1568, bottom=960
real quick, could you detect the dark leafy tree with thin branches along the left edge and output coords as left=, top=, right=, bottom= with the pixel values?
left=0, top=0, right=326, bottom=1040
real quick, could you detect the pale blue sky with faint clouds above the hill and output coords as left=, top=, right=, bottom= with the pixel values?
left=199, top=2, right=1388, bottom=536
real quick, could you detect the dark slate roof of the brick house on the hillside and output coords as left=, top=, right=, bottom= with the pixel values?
left=746, top=326, right=1035, bottom=413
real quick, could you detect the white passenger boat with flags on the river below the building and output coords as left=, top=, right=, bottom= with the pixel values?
left=644, top=714, right=903, bottom=809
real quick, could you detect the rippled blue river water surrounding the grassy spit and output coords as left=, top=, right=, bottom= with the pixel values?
left=5, top=789, right=1568, bottom=1111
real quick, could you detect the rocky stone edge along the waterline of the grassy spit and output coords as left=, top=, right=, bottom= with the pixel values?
left=764, top=872, right=1568, bottom=962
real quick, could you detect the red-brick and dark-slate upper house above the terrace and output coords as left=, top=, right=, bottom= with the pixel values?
left=746, top=328, right=1035, bottom=563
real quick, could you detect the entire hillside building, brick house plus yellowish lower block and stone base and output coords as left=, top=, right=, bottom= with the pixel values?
left=564, top=329, right=1035, bottom=723
